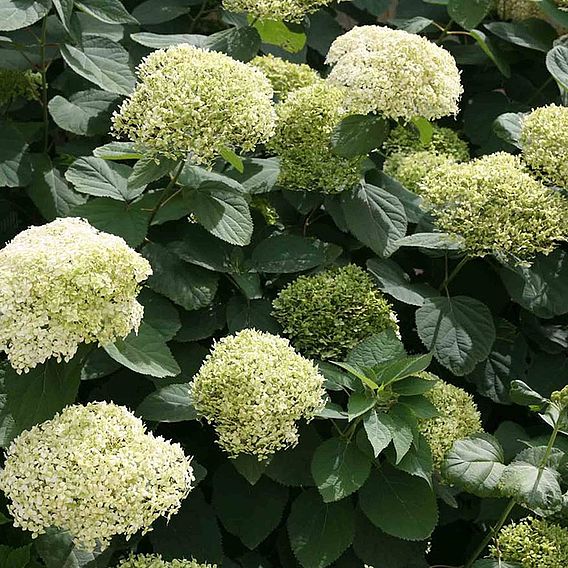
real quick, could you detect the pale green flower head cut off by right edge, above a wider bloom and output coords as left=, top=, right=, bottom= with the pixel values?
left=521, top=104, right=568, bottom=189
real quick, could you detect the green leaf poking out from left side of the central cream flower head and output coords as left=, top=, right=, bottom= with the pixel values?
left=136, top=383, right=197, bottom=422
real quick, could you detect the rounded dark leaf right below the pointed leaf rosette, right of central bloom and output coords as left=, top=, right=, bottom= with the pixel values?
left=312, top=438, right=371, bottom=503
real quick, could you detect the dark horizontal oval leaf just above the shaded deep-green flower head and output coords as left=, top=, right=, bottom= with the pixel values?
left=251, top=235, right=341, bottom=274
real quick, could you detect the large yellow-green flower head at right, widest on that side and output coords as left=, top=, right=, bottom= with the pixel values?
left=419, top=152, right=568, bottom=263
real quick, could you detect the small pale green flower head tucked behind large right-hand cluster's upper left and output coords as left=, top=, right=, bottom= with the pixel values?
left=383, top=150, right=455, bottom=193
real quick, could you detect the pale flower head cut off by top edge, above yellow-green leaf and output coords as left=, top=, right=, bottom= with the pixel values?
left=223, top=0, right=341, bottom=22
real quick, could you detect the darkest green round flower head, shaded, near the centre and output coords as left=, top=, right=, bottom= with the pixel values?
left=272, top=264, right=398, bottom=359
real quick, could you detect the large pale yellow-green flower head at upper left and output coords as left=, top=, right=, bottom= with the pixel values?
left=113, top=44, right=275, bottom=163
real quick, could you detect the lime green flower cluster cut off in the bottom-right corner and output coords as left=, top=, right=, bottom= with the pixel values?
left=490, top=517, right=568, bottom=568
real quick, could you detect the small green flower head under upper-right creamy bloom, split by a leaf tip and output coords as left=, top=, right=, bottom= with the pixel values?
left=383, top=124, right=470, bottom=162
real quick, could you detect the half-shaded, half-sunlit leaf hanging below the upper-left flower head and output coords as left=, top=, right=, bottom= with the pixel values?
left=184, top=182, right=253, bottom=246
